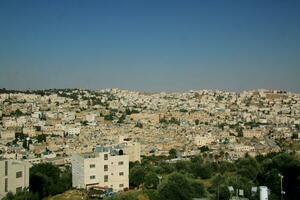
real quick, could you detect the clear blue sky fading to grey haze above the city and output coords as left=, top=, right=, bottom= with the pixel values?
left=0, top=0, right=300, bottom=92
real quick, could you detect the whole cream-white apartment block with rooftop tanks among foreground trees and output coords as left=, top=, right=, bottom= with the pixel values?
left=71, top=147, right=129, bottom=192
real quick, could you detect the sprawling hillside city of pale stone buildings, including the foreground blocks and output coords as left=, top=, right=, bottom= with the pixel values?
left=0, top=89, right=300, bottom=198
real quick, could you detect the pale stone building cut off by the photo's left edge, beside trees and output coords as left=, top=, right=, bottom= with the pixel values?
left=0, top=160, right=31, bottom=199
